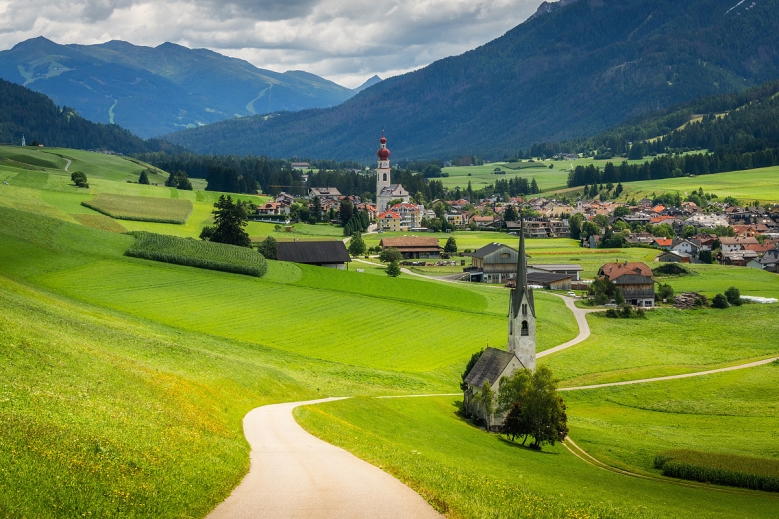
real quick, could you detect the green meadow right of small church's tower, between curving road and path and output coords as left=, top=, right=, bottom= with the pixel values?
left=541, top=305, right=779, bottom=387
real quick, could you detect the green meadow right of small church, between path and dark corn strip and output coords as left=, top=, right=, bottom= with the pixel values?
left=563, top=364, right=779, bottom=474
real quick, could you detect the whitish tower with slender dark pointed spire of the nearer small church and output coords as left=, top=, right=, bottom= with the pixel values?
left=508, top=219, right=536, bottom=371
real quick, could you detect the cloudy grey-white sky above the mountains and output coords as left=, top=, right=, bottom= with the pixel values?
left=0, top=0, right=542, bottom=88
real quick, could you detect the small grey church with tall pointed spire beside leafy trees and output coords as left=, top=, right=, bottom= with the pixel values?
left=463, top=219, right=536, bottom=429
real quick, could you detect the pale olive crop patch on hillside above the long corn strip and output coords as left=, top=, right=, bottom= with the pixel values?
left=81, top=194, right=192, bottom=224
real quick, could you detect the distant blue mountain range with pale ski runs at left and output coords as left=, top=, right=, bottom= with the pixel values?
left=0, top=37, right=381, bottom=138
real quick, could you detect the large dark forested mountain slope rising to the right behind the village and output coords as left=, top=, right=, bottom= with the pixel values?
left=169, top=0, right=779, bottom=160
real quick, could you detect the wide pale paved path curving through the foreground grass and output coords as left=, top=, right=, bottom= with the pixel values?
left=208, top=398, right=442, bottom=519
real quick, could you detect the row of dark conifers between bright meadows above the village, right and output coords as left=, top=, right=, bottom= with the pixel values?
left=568, top=149, right=779, bottom=187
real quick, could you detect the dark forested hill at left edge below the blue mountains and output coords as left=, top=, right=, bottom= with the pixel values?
left=0, top=79, right=177, bottom=154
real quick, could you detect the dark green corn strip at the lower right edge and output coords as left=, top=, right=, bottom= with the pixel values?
left=655, top=450, right=779, bottom=492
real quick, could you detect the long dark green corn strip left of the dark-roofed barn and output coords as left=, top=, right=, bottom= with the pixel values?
left=125, top=231, right=268, bottom=277
